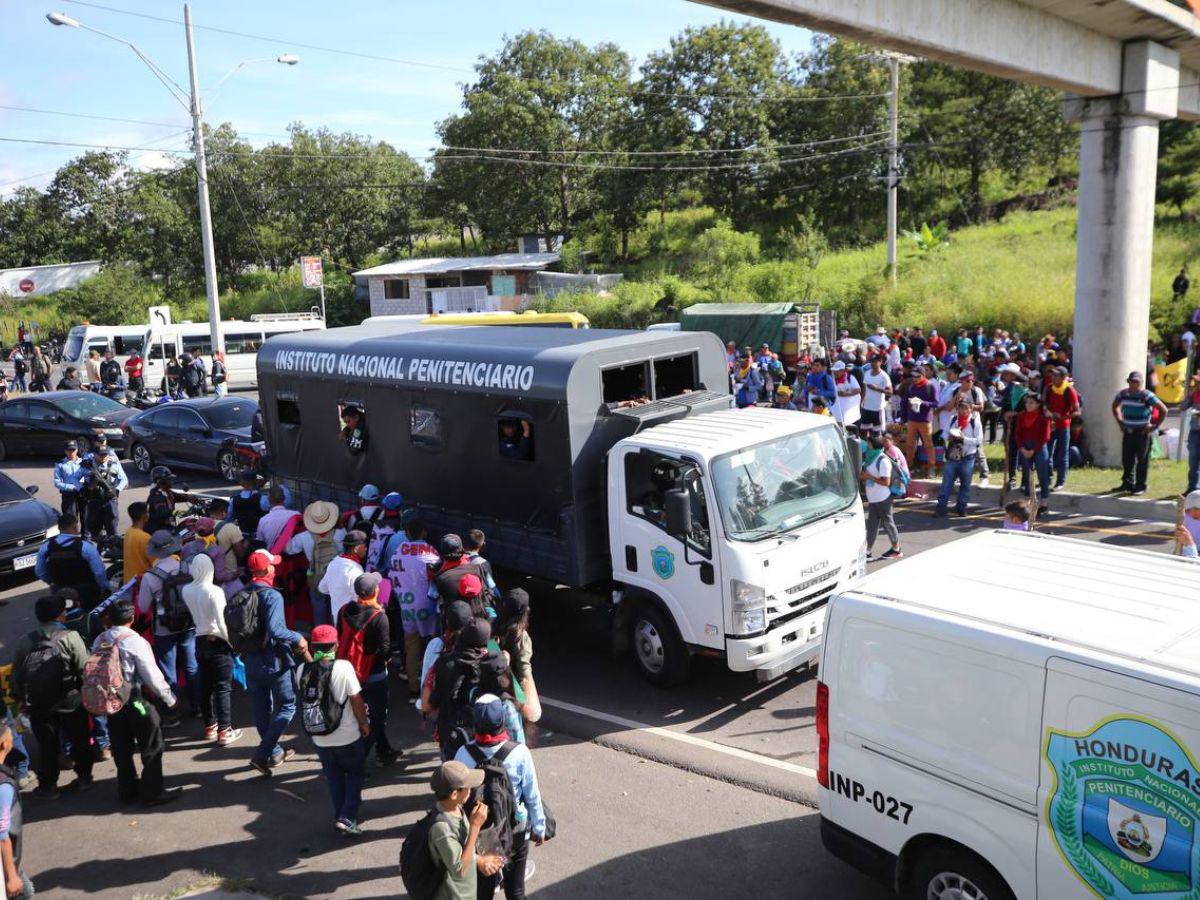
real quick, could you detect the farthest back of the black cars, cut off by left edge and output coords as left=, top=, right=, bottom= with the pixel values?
left=0, top=391, right=134, bottom=461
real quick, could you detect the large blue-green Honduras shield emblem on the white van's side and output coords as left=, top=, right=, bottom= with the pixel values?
left=1045, top=719, right=1200, bottom=900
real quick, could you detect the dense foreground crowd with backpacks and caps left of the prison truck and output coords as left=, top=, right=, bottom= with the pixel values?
left=0, top=468, right=554, bottom=898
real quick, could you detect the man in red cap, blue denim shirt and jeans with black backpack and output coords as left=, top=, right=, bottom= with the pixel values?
left=242, top=550, right=307, bottom=778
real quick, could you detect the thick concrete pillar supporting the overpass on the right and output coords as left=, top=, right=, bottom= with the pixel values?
left=1064, top=41, right=1180, bottom=466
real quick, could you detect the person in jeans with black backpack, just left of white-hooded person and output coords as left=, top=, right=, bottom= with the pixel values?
left=138, top=528, right=200, bottom=728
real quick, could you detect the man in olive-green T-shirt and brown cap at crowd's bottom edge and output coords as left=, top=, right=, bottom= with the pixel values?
left=430, top=760, right=504, bottom=900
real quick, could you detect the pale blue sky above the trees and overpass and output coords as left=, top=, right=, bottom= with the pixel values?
left=0, top=0, right=811, bottom=196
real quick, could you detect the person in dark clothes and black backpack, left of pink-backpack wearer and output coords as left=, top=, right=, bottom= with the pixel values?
left=11, top=595, right=92, bottom=800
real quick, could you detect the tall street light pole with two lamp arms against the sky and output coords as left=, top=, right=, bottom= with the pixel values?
left=46, top=4, right=300, bottom=353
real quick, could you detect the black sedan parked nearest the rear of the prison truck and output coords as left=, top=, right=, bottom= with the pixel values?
left=121, top=397, right=258, bottom=481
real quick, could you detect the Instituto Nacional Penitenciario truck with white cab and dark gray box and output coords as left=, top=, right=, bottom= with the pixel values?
left=258, top=323, right=865, bottom=684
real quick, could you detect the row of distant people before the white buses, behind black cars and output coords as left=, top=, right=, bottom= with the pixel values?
left=0, top=343, right=229, bottom=400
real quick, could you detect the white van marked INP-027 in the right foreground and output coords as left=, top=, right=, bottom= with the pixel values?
left=817, top=532, right=1200, bottom=900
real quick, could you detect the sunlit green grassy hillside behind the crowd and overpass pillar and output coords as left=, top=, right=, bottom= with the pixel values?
left=541, top=208, right=1200, bottom=336
